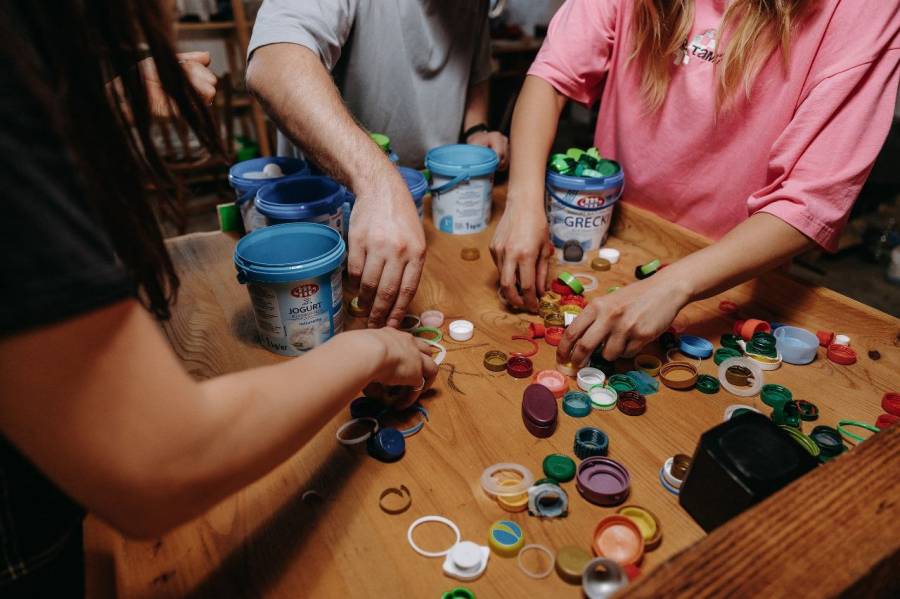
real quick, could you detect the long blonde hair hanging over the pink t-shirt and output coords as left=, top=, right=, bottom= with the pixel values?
left=631, top=0, right=814, bottom=111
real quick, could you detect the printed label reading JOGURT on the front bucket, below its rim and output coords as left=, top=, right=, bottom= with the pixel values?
left=247, top=269, right=344, bottom=356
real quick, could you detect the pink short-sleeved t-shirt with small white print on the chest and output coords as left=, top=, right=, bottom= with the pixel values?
left=529, top=0, right=900, bottom=251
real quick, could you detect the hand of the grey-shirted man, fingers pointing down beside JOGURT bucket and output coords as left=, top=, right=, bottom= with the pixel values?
left=347, top=169, right=425, bottom=328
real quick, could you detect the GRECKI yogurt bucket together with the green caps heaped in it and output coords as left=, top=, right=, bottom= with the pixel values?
left=544, top=148, right=625, bottom=252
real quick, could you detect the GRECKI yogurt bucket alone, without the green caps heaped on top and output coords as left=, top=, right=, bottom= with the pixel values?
left=544, top=163, right=625, bottom=252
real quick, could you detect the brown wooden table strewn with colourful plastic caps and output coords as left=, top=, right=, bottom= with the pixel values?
left=86, top=190, right=900, bottom=599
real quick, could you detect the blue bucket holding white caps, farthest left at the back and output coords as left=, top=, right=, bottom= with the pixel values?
left=228, top=156, right=309, bottom=232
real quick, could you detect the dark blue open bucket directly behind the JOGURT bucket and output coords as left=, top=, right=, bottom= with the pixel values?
left=254, top=177, right=346, bottom=233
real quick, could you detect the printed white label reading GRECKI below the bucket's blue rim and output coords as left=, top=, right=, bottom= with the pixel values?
left=544, top=188, right=618, bottom=251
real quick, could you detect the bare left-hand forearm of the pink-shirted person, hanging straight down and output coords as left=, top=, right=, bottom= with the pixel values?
left=507, top=77, right=566, bottom=210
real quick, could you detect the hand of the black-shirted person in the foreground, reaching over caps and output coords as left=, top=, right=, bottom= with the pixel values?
left=356, top=327, right=438, bottom=410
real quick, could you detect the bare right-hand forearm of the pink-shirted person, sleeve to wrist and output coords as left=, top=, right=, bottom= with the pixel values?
left=654, top=212, right=815, bottom=302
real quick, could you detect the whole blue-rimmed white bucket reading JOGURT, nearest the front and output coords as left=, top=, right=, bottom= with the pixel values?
left=234, top=223, right=347, bottom=356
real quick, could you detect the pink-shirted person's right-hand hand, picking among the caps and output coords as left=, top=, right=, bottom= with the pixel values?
left=556, top=271, right=691, bottom=365
